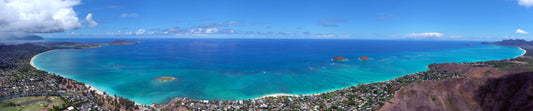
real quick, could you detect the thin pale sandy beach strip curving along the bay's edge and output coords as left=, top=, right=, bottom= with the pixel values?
left=30, top=44, right=527, bottom=106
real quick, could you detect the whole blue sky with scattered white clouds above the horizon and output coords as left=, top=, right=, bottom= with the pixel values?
left=0, top=0, right=533, bottom=41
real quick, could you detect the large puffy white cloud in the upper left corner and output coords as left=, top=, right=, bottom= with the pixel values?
left=0, top=0, right=92, bottom=37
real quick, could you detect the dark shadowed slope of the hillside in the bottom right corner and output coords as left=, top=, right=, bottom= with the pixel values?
left=475, top=72, right=533, bottom=111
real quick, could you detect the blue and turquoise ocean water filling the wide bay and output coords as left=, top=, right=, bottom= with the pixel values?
left=34, top=39, right=524, bottom=104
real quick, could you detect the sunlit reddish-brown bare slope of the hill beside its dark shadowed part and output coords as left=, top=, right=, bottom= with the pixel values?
left=380, top=78, right=483, bottom=111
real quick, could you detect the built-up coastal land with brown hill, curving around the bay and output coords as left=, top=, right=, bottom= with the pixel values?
left=0, top=40, right=533, bottom=110
